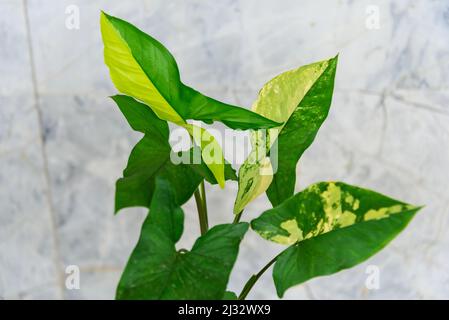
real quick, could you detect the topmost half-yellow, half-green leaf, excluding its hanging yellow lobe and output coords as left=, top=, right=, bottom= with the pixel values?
left=100, top=12, right=280, bottom=129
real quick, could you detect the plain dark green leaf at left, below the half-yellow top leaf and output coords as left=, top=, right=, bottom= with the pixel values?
left=112, top=95, right=236, bottom=212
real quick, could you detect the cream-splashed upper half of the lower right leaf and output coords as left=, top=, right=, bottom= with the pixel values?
left=253, top=182, right=418, bottom=245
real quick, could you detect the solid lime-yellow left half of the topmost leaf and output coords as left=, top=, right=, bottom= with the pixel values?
left=100, top=13, right=185, bottom=124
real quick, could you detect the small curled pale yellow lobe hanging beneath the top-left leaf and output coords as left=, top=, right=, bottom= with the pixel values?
left=182, top=123, right=225, bottom=188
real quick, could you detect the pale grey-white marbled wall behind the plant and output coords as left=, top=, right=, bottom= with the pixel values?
left=0, top=0, right=449, bottom=299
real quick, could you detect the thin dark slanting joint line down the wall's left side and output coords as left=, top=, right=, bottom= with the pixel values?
left=22, top=0, right=64, bottom=299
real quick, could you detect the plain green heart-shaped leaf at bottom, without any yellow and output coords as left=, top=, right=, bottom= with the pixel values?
left=116, top=179, right=248, bottom=300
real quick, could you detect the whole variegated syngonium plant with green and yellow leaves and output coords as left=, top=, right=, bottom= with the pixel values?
left=101, top=13, right=420, bottom=299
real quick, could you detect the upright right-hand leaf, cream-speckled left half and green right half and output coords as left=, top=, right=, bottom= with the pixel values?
left=234, top=57, right=337, bottom=213
